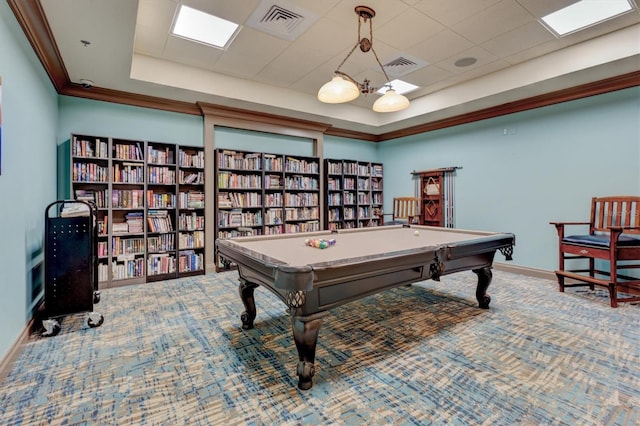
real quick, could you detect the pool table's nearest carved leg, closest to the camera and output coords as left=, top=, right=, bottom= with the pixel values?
left=291, top=308, right=328, bottom=390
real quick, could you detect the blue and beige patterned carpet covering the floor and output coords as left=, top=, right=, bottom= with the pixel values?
left=0, top=271, right=640, bottom=425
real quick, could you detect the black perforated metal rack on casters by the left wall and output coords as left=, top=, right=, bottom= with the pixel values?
left=42, top=200, right=104, bottom=336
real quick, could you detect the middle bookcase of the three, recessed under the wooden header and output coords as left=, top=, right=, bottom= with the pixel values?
left=214, top=148, right=321, bottom=271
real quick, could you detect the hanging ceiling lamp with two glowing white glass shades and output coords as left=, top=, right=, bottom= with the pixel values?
left=318, top=6, right=409, bottom=112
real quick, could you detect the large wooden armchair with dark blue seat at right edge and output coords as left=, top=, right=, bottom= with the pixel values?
left=550, top=196, right=640, bottom=308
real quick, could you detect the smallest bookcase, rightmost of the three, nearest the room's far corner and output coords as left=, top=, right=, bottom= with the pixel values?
left=324, top=159, right=383, bottom=230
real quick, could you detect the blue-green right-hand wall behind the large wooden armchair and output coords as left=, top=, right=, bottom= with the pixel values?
left=379, top=87, right=640, bottom=270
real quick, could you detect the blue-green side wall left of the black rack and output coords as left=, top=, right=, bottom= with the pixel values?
left=0, top=1, right=58, bottom=358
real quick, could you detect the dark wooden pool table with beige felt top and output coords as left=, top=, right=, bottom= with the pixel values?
left=216, top=225, right=515, bottom=390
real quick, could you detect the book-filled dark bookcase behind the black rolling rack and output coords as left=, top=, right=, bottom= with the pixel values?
left=70, top=135, right=205, bottom=288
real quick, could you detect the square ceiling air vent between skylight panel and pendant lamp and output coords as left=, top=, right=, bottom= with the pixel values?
left=247, top=0, right=318, bottom=40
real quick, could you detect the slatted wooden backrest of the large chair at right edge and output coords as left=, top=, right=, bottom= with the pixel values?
left=591, top=196, right=640, bottom=234
